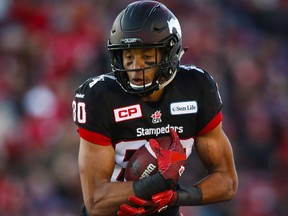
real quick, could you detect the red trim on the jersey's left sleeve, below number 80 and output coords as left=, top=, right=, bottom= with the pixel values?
left=78, top=127, right=112, bottom=146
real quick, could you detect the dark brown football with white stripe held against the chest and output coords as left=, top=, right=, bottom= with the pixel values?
left=125, top=136, right=172, bottom=181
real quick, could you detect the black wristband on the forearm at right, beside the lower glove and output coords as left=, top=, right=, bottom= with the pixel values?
left=175, top=186, right=202, bottom=206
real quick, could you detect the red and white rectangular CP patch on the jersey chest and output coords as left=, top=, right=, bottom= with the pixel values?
left=113, top=104, right=142, bottom=122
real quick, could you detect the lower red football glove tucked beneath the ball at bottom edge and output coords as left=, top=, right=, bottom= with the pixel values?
left=117, top=190, right=177, bottom=216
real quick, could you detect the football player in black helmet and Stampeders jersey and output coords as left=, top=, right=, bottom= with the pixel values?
left=72, top=1, right=238, bottom=216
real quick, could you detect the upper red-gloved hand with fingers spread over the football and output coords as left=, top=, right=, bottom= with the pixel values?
left=149, top=128, right=187, bottom=187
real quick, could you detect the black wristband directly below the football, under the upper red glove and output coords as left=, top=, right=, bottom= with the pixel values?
left=133, top=172, right=169, bottom=199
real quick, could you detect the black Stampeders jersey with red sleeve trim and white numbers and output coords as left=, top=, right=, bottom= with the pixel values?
left=72, top=65, right=222, bottom=181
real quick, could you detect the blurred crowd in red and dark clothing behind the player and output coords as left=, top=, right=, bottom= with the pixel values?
left=0, top=0, right=288, bottom=216
